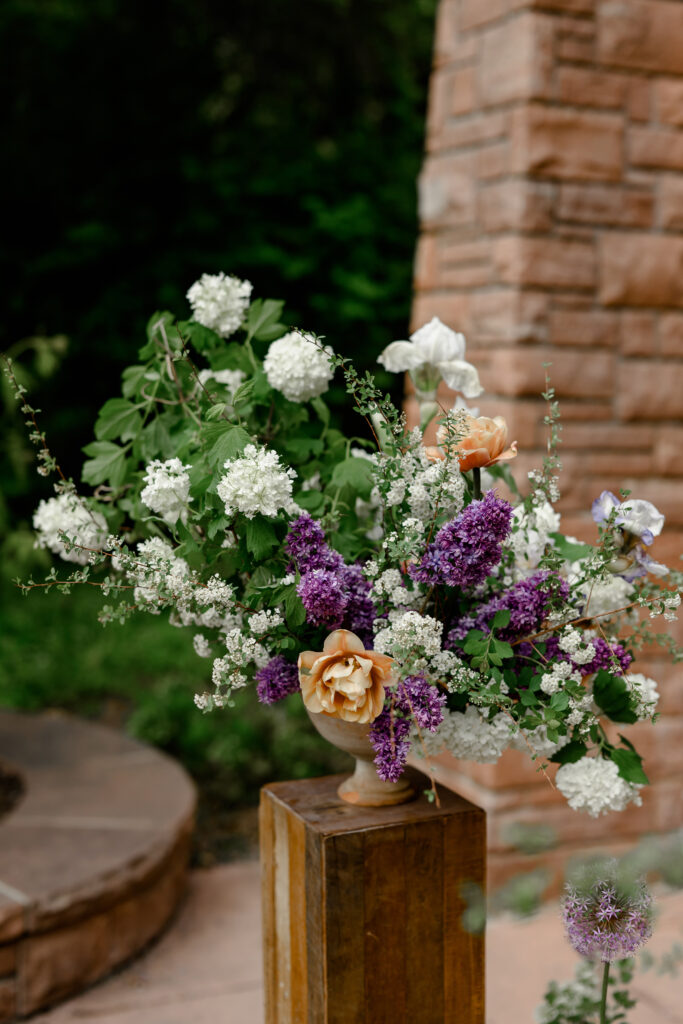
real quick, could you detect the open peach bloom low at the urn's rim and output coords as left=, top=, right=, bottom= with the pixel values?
left=299, top=630, right=394, bottom=723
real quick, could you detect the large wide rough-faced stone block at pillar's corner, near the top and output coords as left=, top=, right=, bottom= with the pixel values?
left=512, top=103, right=624, bottom=181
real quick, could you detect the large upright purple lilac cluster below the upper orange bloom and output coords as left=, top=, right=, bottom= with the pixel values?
left=409, top=490, right=512, bottom=587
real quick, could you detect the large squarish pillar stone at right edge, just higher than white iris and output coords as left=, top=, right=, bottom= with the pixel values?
left=598, top=232, right=683, bottom=306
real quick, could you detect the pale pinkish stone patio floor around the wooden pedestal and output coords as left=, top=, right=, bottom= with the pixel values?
left=34, top=861, right=683, bottom=1024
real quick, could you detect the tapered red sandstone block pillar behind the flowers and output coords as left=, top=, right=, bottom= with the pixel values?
left=413, top=0, right=683, bottom=888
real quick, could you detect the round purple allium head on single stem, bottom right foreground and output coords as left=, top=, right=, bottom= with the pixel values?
left=562, top=861, right=652, bottom=963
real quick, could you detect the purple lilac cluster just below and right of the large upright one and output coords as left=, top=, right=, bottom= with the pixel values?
left=447, top=569, right=569, bottom=647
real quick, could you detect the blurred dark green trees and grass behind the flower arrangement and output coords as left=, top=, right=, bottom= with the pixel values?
left=0, top=0, right=437, bottom=823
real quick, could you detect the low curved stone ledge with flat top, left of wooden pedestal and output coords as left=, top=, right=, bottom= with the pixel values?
left=0, top=711, right=196, bottom=1024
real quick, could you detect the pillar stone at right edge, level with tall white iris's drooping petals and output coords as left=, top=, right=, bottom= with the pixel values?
left=614, top=359, right=683, bottom=421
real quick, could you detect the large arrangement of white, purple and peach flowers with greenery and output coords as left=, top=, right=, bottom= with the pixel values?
left=8, top=274, right=682, bottom=815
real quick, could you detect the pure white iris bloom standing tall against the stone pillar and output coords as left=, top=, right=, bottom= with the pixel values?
left=377, top=316, right=483, bottom=398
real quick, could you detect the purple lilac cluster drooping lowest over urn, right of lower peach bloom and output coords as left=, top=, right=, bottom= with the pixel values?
left=370, top=676, right=445, bottom=782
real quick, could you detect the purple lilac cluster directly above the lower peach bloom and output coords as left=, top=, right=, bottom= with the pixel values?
left=286, top=513, right=377, bottom=643
